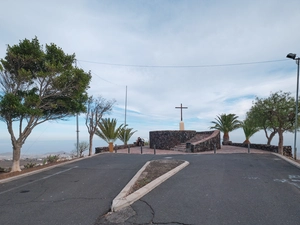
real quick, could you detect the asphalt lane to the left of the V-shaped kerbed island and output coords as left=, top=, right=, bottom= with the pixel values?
left=0, top=154, right=158, bottom=225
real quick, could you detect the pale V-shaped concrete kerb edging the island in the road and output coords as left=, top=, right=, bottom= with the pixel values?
left=111, top=161, right=189, bottom=212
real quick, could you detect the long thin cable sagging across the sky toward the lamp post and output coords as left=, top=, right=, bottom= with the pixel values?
left=78, top=59, right=288, bottom=68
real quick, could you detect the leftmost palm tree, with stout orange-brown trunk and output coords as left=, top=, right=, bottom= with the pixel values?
left=95, top=118, right=123, bottom=152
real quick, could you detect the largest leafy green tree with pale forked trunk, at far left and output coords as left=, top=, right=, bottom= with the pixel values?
left=0, top=37, right=91, bottom=171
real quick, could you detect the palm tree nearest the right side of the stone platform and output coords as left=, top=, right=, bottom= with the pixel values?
left=210, top=114, right=241, bottom=144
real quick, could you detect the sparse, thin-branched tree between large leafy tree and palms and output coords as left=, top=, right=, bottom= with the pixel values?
left=85, top=96, right=115, bottom=155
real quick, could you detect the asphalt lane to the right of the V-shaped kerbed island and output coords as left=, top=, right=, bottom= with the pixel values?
left=114, top=154, right=300, bottom=225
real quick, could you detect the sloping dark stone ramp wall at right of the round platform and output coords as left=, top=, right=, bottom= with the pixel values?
left=187, top=130, right=221, bottom=152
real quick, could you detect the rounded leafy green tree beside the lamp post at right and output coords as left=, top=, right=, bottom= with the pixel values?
left=249, top=91, right=299, bottom=154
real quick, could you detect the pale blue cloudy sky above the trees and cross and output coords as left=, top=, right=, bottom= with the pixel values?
left=0, top=0, right=300, bottom=157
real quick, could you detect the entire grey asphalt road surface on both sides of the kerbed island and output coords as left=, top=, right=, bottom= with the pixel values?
left=0, top=154, right=300, bottom=225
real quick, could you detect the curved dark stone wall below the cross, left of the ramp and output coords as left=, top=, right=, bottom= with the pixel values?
left=149, top=130, right=197, bottom=150
